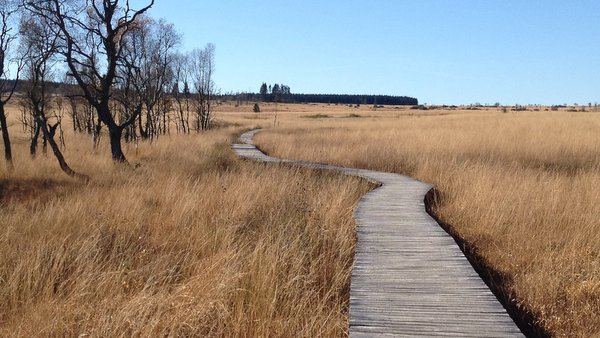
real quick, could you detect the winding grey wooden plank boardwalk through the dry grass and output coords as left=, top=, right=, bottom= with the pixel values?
left=232, top=130, right=523, bottom=337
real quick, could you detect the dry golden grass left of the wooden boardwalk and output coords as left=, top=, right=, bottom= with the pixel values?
left=0, top=106, right=369, bottom=337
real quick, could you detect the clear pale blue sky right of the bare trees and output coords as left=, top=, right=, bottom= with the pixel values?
left=150, top=0, right=600, bottom=105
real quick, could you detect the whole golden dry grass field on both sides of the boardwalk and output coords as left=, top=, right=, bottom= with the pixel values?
left=0, top=103, right=600, bottom=336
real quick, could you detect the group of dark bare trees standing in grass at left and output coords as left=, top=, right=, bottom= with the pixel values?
left=0, top=0, right=215, bottom=178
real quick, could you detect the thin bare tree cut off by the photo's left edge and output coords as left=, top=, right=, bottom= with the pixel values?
left=0, top=0, right=20, bottom=171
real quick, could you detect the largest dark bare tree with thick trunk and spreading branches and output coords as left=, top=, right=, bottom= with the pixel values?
left=25, top=0, right=154, bottom=163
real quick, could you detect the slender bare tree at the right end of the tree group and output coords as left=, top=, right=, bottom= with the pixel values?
left=190, top=43, right=215, bottom=131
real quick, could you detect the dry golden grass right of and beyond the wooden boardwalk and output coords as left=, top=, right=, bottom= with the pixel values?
left=252, top=106, right=600, bottom=336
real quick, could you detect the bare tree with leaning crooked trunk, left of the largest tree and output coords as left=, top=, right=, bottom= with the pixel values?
left=20, top=11, right=89, bottom=181
